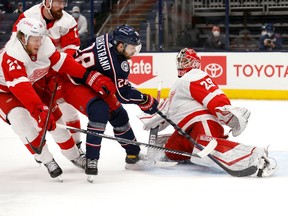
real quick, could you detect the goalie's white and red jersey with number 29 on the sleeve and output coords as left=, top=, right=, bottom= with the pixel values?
left=166, top=69, right=230, bottom=130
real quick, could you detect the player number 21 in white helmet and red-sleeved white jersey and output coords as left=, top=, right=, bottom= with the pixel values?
left=0, top=18, right=115, bottom=178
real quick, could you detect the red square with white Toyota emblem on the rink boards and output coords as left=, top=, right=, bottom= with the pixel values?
left=201, top=56, right=227, bottom=85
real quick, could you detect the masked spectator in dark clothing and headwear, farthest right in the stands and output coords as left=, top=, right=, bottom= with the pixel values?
left=259, top=23, right=282, bottom=51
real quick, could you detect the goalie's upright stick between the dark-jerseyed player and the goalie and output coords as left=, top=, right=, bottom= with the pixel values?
left=147, top=81, right=162, bottom=164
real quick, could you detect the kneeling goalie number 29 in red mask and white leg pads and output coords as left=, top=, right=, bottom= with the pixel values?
left=140, top=48, right=276, bottom=177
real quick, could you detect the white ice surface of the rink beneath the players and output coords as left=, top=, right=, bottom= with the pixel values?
left=0, top=100, right=288, bottom=216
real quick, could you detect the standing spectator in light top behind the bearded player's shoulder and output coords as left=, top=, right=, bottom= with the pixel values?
left=72, top=6, right=88, bottom=49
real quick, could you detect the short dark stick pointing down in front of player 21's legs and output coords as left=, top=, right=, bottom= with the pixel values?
left=26, top=75, right=58, bottom=154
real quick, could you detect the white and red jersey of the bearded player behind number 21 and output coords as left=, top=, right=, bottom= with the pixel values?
left=13, top=3, right=80, bottom=55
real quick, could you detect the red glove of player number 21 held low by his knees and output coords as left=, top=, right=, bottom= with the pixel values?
left=32, top=105, right=56, bottom=131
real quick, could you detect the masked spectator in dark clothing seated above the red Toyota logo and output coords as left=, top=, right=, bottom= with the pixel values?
left=205, top=26, right=226, bottom=50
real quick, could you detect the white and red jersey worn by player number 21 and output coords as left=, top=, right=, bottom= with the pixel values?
left=0, top=37, right=86, bottom=112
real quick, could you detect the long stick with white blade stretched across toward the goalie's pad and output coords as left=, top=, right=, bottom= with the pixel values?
left=57, top=123, right=215, bottom=158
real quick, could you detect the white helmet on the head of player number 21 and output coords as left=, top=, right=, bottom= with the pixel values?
left=17, top=18, right=46, bottom=45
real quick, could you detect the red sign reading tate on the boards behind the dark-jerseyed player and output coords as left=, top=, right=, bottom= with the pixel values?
left=129, top=56, right=155, bottom=85
